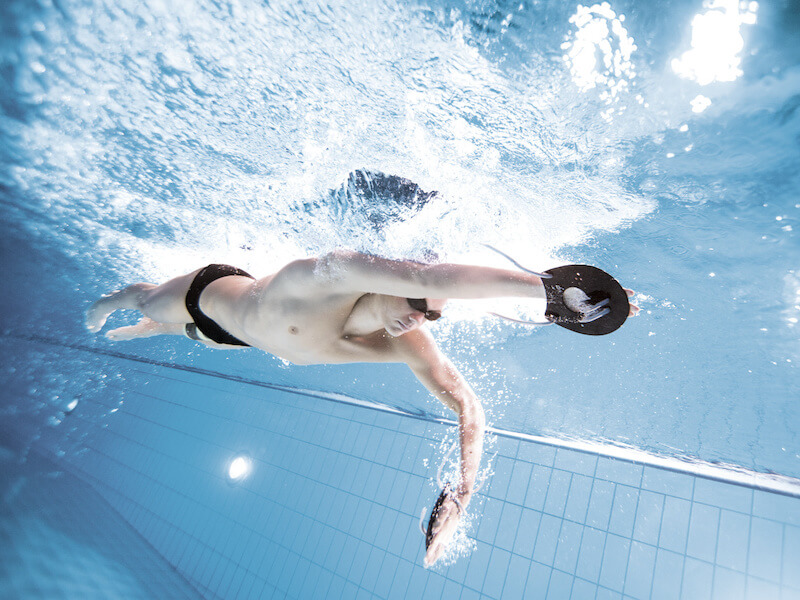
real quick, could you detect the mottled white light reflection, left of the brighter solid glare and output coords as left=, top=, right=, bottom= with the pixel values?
left=561, top=2, right=636, bottom=104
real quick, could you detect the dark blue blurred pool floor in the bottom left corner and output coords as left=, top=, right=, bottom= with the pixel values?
left=0, top=453, right=202, bottom=600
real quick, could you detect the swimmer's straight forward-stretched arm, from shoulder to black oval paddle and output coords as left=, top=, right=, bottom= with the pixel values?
left=315, top=250, right=545, bottom=299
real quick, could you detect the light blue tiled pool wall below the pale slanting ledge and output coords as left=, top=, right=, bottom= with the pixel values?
left=57, top=358, right=800, bottom=600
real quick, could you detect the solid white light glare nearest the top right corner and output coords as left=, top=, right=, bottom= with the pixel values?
left=672, top=0, right=758, bottom=85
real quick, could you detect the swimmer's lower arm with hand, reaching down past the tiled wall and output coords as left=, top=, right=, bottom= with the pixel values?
left=396, top=329, right=486, bottom=565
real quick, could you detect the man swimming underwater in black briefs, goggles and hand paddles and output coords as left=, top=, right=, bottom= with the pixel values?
left=86, top=250, right=639, bottom=566
